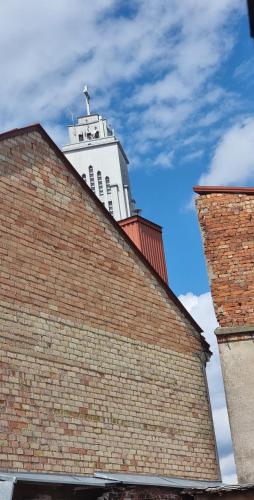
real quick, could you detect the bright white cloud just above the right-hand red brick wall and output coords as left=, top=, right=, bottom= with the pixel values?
left=199, top=117, right=254, bottom=185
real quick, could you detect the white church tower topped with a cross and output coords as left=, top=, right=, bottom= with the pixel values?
left=62, top=86, right=137, bottom=221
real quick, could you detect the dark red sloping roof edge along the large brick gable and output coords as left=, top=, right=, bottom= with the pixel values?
left=0, top=123, right=208, bottom=355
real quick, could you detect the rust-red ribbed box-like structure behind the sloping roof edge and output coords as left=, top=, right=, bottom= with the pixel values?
left=119, top=215, right=168, bottom=283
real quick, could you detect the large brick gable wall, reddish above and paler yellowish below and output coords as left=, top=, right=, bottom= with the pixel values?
left=0, top=128, right=218, bottom=479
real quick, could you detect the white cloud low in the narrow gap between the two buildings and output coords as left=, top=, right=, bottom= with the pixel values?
left=179, top=292, right=236, bottom=483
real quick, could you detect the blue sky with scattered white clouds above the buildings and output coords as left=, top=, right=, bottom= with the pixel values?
left=0, top=0, right=254, bottom=480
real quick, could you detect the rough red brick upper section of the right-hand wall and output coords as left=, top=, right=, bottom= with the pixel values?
left=197, top=192, right=254, bottom=327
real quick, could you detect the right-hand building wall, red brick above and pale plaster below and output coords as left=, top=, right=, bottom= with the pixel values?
left=194, top=186, right=254, bottom=483
